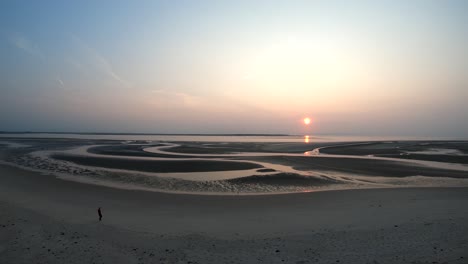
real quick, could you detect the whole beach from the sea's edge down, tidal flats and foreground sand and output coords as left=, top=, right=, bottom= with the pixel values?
left=0, top=139, right=468, bottom=263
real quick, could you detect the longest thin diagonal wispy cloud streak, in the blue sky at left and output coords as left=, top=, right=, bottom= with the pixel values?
left=70, top=34, right=132, bottom=87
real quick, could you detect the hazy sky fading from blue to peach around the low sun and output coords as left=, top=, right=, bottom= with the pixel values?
left=0, top=0, right=468, bottom=137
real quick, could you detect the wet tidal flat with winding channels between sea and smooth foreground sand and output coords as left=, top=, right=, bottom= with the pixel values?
left=0, top=139, right=468, bottom=195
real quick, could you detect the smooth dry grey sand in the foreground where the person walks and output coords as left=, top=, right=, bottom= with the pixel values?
left=0, top=165, right=468, bottom=263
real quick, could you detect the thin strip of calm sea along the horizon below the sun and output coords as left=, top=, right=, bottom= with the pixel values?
left=0, top=133, right=456, bottom=143
